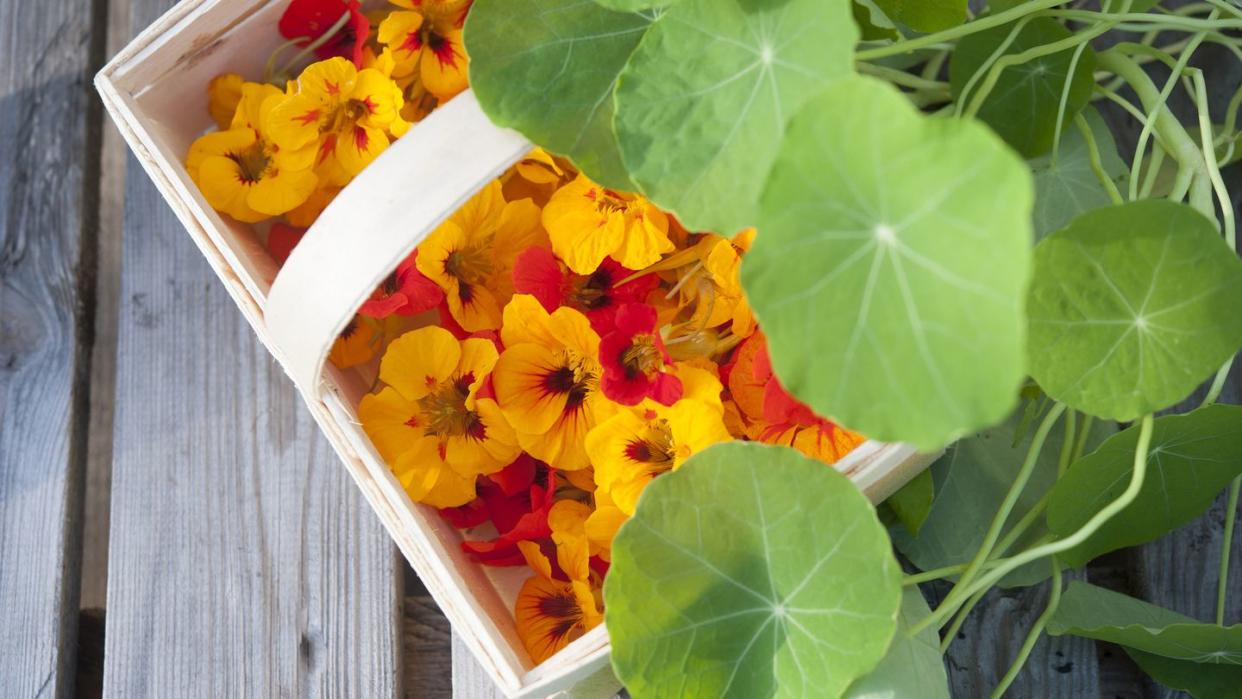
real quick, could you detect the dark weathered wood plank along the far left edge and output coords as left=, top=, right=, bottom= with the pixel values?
left=0, top=0, right=102, bottom=697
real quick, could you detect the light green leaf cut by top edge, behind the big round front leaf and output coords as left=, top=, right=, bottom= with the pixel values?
left=615, top=0, right=858, bottom=235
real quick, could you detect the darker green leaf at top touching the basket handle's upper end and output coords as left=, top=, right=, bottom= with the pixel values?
left=466, top=0, right=657, bottom=190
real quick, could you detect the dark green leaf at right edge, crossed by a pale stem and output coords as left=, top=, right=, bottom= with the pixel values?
left=1047, top=405, right=1242, bottom=567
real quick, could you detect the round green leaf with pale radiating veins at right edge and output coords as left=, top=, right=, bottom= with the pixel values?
left=1027, top=200, right=1242, bottom=420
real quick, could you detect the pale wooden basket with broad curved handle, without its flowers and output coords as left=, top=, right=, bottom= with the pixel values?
left=96, top=0, right=934, bottom=697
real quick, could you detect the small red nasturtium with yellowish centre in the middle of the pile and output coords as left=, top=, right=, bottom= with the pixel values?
left=600, top=303, right=682, bottom=405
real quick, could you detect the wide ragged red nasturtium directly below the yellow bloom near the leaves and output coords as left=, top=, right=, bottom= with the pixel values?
left=513, top=246, right=660, bottom=335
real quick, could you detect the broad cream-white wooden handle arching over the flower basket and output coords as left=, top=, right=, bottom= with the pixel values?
left=265, top=91, right=533, bottom=399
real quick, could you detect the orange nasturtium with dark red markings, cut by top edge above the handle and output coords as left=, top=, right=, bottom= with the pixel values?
left=379, top=0, right=469, bottom=99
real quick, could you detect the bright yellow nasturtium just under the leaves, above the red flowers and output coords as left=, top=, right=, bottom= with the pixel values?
left=543, top=174, right=673, bottom=274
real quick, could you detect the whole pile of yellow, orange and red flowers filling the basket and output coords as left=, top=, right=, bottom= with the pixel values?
left=186, top=0, right=862, bottom=663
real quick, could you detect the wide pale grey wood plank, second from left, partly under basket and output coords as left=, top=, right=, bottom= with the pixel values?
left=104, top=145, right=400, bottom=698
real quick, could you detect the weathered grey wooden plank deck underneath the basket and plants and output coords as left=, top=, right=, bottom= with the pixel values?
left=0, top=0, right=1242, bottom=698
